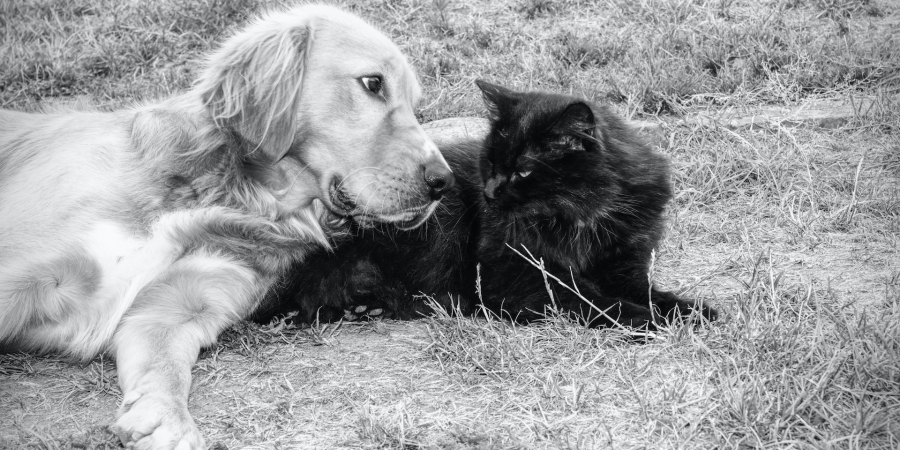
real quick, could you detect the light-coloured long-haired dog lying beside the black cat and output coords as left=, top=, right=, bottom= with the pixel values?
left=0, top=5, right=453, bottom=449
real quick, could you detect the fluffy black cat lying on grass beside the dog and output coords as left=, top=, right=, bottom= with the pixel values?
left=256, top=81, right=716, bottom=327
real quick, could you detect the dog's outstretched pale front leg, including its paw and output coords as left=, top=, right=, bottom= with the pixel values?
left=112, top=256, right=259, bottom=450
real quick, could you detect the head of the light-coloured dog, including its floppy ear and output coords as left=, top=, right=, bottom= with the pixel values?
left=198, top=5, right=453, bottom=228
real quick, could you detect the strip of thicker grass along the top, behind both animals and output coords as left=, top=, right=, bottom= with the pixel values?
left=0, top=0, right=900, bottom=116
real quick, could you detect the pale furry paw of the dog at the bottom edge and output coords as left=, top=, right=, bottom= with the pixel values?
left=110, top=392, right=205, bottom=450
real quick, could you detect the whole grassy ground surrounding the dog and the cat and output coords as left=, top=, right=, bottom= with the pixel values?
left=0, top=0, right=900, bottom=449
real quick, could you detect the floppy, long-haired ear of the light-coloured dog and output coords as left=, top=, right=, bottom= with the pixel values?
left=197, top=24, right=311, bottom=161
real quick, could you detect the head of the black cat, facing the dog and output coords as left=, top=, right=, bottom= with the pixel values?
left=476, top=80, right=611, bottom=218
